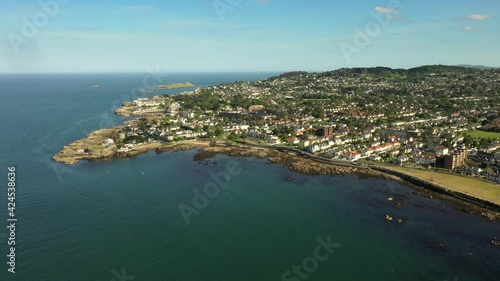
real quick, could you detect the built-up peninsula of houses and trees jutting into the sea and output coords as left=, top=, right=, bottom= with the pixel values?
left=53, top=65, right=500, bottom=217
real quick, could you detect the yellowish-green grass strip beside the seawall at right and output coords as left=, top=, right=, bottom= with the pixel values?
left=385, top=167, right=500, bottom=204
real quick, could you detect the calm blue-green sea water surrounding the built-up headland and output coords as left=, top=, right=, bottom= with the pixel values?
left=0, top=73, right=500, bottom=281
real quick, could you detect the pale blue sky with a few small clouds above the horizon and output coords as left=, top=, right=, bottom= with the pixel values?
left=0, top=0, right=500, bottom=73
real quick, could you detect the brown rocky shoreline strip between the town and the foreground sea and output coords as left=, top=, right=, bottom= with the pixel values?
left=52, top=133, right=500, bottom=220
